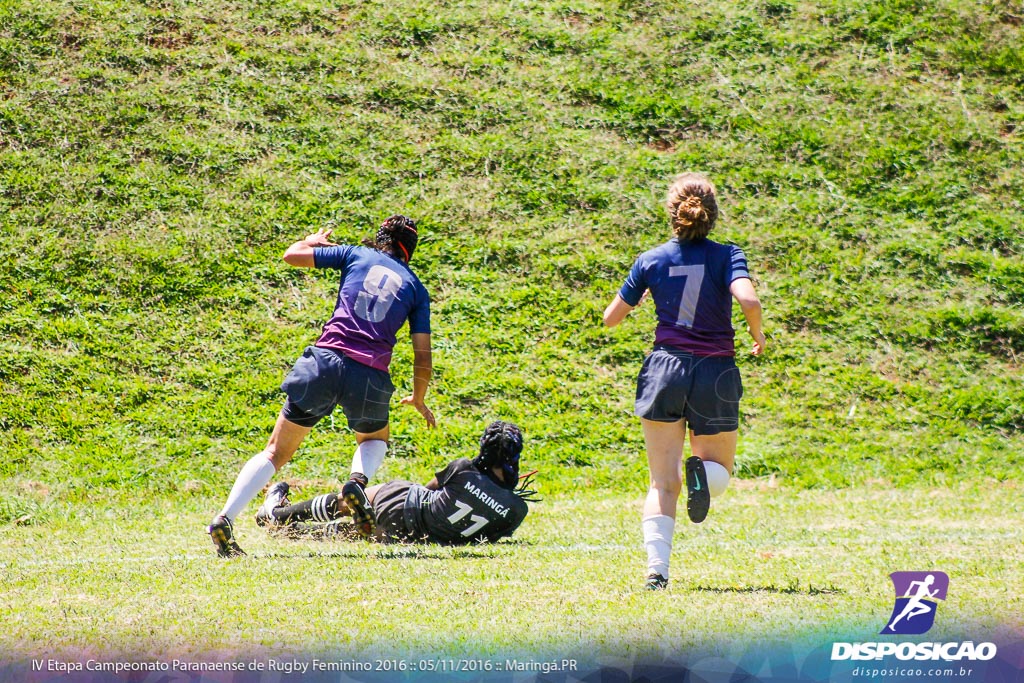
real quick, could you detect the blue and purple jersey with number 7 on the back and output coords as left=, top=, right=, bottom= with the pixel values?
left=618, top=240, right=750, bottom=355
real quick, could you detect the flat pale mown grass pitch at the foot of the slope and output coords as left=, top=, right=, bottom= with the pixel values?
left=0, top=482, right=1024, bottom=657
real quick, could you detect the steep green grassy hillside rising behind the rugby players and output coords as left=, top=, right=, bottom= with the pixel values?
left=0, top=0, right=1024, bottom=521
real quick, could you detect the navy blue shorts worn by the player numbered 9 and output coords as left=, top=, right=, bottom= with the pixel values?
left=281, top=346, right=394, bottom=434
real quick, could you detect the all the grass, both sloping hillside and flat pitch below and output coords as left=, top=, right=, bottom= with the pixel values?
left=0, top=0, right=1024, bottom=675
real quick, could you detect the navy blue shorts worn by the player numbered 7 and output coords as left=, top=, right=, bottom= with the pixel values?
left=634, top=346, right=743, bottom=436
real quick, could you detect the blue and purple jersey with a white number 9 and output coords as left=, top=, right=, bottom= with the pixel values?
left=313, top=245, right=430, bottom=371
